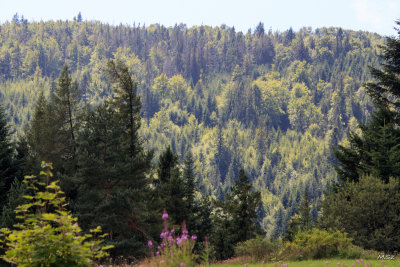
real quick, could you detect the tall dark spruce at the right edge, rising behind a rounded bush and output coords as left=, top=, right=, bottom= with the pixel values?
left=334, top=21, right=400, bottom=182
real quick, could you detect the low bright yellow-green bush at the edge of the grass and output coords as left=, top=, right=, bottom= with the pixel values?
left=282, top=228, right=351, bottom=260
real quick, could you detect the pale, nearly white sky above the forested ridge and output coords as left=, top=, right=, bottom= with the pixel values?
left=0, top=0, right=400, bottom=36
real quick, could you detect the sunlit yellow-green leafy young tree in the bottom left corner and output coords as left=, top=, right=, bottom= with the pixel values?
left=1, top=162, right=111, bottom=267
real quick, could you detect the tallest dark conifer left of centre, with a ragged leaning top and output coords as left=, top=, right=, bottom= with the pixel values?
left=74, top=63, right=152, bottom=258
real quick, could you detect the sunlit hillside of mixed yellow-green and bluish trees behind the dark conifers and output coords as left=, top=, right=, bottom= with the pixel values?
left=0, top=15, right=383, bottom=237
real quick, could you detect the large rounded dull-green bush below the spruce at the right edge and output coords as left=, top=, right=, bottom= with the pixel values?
left=320, top=175, right=400, bottom=252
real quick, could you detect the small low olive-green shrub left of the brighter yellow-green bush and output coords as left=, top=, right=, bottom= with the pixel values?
left=235, top=237, right=279, bottom=260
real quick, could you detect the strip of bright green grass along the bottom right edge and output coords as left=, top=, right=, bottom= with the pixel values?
left=211, top=259, right=400, bottom=267
